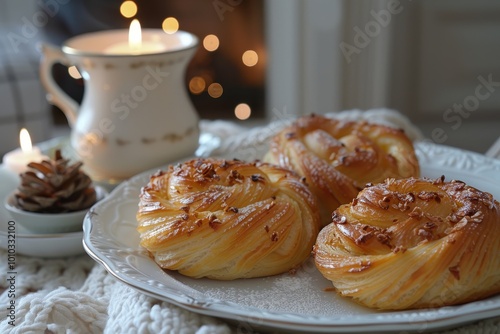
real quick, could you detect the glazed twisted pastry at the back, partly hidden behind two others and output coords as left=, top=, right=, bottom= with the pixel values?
left=264, top=115, right=420, bottom=225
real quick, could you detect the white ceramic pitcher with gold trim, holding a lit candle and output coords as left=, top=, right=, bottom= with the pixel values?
left=40, top=29, right=199, bottom=181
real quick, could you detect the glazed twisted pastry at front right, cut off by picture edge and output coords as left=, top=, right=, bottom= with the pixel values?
left=314, top=177, right=500, bottom=310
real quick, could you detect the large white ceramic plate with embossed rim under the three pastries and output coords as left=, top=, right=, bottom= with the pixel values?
left=84, top=143, right=500, bottom=333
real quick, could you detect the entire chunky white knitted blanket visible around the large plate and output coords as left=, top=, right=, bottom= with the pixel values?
left=0, top=110, right=500, bottom=334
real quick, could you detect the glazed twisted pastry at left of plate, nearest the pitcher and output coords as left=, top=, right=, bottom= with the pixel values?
left=137, top=159, right=319, bottom=280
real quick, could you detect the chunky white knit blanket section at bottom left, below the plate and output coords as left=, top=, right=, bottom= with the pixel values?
left=0, top=250, right=231, bottom=334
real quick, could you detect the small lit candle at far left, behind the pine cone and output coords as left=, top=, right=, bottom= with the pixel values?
left=2, top=128, right=47, bottom=173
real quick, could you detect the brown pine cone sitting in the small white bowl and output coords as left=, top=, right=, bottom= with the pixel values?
left=14, top=150, right=96, bottom=213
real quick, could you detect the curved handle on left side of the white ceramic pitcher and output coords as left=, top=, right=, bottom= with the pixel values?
left=40, top=43, right=79, bottom=127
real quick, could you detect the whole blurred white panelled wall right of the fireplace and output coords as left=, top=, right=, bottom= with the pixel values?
left=266, top=0, right=500, bottom=152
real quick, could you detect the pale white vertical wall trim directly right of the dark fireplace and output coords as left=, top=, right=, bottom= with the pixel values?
left=265, top=0, right=343, bottom=119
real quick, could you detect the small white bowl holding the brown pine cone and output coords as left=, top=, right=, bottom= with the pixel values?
left=5, top=187, right=107, bottom=234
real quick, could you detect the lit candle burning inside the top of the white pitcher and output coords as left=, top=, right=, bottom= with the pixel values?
left=104, top=19, right=167, bottom=55
